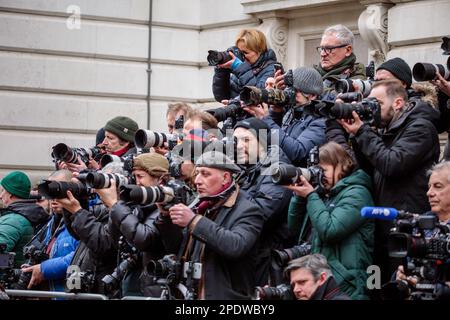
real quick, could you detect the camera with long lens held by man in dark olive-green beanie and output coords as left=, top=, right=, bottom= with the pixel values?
left=52, top=143, right=103, bottom=165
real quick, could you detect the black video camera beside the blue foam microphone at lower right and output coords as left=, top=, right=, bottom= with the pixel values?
left=382, top=213, right=450, bottom=300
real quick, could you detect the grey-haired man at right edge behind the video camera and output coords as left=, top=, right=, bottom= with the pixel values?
left=396, top=161, right=450, bottom=298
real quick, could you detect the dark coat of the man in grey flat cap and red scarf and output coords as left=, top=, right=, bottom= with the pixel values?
left=158, top=190, right=264, bottom=300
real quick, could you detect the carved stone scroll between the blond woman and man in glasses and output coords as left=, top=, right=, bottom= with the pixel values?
left=259, top=18, right=289, bottom=65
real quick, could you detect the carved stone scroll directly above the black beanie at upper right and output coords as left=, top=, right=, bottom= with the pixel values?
left=358, top=3, right=392, bottom=66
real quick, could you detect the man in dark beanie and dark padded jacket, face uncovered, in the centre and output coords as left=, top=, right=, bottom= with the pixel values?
left=233, top=118, right=292, bottom=286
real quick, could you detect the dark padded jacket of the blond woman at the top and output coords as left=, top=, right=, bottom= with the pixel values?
left=212, top=49, right=277, bottom=102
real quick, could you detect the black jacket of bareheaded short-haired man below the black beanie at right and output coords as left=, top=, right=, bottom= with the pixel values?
left=354, top=100, right=440, bottom=213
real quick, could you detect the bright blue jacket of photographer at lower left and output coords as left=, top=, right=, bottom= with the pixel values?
left=41, top=215, right=79, bottom=291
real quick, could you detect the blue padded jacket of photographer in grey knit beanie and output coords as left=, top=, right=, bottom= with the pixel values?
left=263, top=107, right=326, bottom=167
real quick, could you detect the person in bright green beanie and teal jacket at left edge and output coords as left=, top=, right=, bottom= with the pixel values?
left=0, top=171, right=50, bottom=267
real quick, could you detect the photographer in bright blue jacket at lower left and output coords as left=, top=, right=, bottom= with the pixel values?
left=22, top=170, right=79, bottom=291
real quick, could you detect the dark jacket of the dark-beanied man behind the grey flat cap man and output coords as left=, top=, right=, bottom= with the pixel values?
left=239, top=146, right=292, bottom=286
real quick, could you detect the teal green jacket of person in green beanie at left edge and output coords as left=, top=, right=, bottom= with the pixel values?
left=0, top=201, right=49, bottom=267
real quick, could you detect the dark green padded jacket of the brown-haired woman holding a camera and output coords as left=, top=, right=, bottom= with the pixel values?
left=288, top=170, right=374, bottom=300
